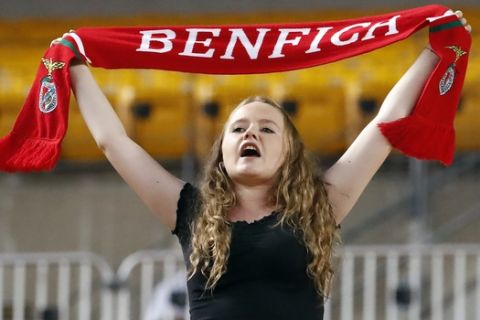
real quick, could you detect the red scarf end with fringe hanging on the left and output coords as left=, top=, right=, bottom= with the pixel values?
left=0, top=47, right=75, bottom=172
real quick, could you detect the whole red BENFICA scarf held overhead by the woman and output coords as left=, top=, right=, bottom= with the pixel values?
left=0, top=5, right=471, bottom=171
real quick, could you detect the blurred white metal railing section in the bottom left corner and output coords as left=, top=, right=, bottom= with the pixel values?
left=0, top=252, right=114, bottom=320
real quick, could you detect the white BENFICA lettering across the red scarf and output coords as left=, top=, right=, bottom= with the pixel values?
left=136, top=15, right=400, bottom=60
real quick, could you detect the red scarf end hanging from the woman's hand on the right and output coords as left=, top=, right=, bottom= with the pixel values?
left=379, top=16, right=471, bottom=165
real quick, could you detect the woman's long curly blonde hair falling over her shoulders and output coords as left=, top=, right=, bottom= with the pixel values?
left=188, top=96, right=337, bottom=297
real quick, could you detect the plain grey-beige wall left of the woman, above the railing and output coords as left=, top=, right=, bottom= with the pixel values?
left=0, top=172, right=175, bottom=264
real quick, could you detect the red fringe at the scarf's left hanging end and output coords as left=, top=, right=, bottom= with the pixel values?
left=0, top=133, right=61, bottom=172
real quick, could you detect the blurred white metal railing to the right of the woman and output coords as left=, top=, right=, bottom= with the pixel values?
left=332, top=245, right=480, bottom=320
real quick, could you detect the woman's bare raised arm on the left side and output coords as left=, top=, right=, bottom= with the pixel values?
left=70, top=64, right=184, bottom=230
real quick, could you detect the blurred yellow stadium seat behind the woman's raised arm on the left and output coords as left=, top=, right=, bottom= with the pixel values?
left=62, top=70, right=189, bottom=161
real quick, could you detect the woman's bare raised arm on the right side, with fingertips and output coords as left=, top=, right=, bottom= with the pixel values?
left=325, top=11, right=471, bottom=223
